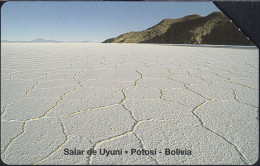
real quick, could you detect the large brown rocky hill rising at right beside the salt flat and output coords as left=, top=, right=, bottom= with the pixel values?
left=103, top=12, right=254, bottom=45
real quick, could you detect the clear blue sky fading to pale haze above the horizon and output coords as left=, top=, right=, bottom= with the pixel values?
left=1, top=1, right=219, bottom=42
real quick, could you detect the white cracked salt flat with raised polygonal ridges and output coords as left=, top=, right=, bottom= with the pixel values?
left=1, top=43, right=259, bottom=165
